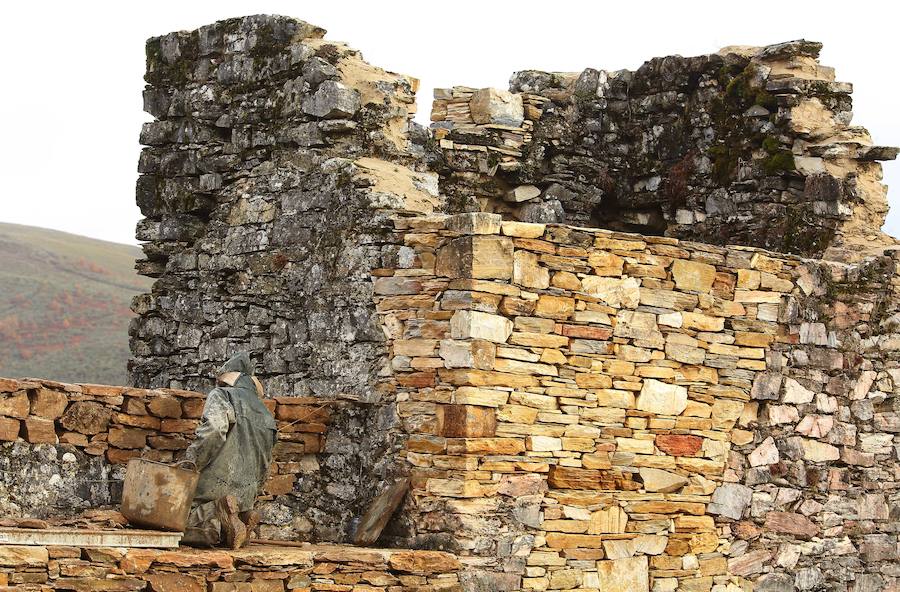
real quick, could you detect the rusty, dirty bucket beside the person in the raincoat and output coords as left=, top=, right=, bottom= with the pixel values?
left=122, top=458, right=200, bottom=532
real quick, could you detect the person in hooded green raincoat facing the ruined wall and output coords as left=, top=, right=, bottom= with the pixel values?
left=178, top=352, right=277, bottom=549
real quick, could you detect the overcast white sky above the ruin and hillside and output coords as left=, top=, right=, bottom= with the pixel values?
left=0, top=0, right=900, bottom=243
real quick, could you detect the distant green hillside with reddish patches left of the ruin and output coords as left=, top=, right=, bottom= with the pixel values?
left=0, top=223, right=152, bottom=384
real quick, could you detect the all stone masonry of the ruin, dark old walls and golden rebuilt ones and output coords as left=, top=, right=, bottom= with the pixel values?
left=0, top=16, right=900, bottom=592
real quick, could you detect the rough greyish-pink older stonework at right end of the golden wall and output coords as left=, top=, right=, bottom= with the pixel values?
left=711, top=252, right=900, bottom=592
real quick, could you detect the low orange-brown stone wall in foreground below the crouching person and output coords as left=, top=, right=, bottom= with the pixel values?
left=0, top=545, right=460, bottom=592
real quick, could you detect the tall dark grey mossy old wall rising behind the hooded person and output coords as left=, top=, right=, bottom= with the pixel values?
left=129, top=16, right=439, bottom=541
